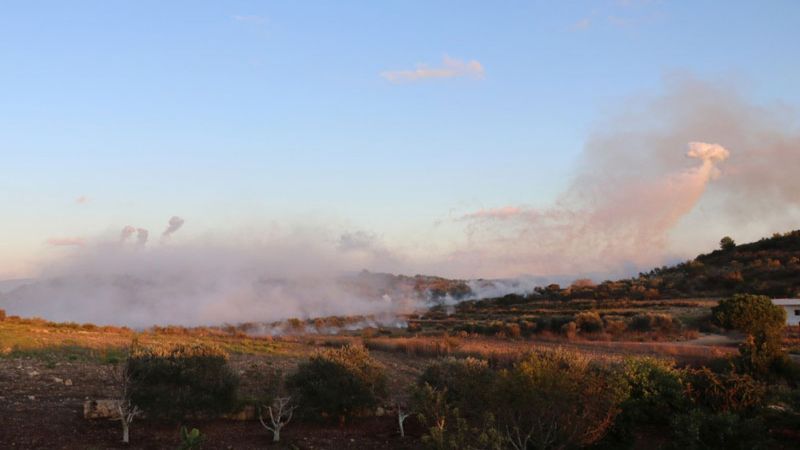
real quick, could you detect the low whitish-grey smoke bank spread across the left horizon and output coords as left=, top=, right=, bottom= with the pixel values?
left=0, top=228, right=423, bottom=327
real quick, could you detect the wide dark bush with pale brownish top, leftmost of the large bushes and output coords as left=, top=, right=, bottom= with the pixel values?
left=125, top=344, right=239, bottom=420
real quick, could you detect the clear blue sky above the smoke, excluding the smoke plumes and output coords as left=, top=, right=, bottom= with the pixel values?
left=0, top=0, right=800, bottom=276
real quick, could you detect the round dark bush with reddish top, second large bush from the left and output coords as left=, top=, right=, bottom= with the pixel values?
left=286, top=344, right=386, bottom=421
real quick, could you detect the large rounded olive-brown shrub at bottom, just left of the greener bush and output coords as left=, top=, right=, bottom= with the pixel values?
left=493, top=350, right=625, bottom=448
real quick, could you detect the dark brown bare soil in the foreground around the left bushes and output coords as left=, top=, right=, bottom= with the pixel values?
left=0, top=353, right=432, bottom=449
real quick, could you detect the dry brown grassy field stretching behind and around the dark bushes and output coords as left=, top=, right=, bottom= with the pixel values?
left=0, top=300, right=764, bottom=449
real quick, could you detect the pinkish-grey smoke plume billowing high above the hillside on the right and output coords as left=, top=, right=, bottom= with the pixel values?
left=454, top=76, right=800, bottom=276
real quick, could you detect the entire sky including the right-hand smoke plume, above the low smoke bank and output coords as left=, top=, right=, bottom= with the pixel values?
left=0, top=0, right=800, bottom=279
